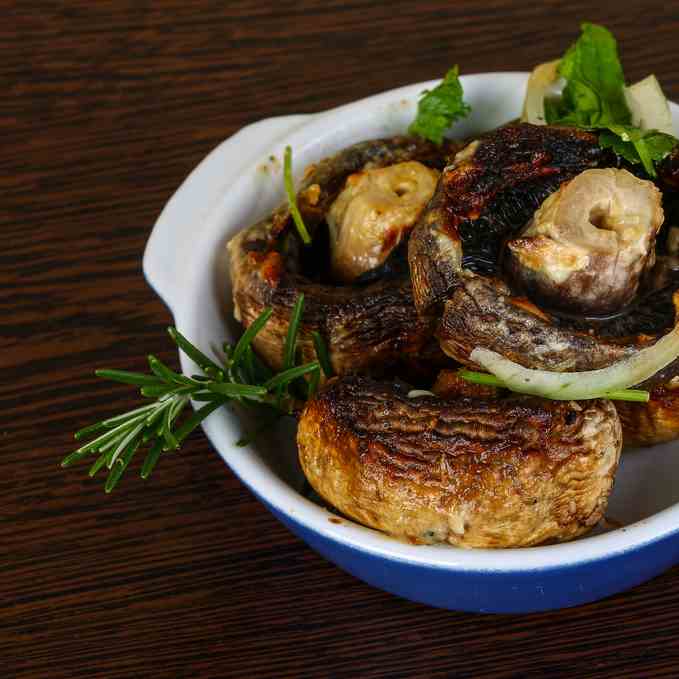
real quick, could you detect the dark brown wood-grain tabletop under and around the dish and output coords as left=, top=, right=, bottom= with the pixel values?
left=7, top=0, right=679, bottom=679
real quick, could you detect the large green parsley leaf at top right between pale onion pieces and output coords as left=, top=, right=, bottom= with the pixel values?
left=545, top=23, right=678, bottom=177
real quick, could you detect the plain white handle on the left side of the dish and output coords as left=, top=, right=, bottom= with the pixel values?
left=143, top=115, right=311, bottom=314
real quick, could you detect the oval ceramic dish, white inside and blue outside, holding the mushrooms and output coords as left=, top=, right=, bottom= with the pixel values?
left=144, top=73, right=679, bottom=613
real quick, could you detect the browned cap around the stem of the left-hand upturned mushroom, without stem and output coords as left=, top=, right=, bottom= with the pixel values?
left=228, top=137, right=454, bottom=374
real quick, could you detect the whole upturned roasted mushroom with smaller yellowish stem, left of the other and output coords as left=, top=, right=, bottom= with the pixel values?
left=228, top=137, right=455, bottom=374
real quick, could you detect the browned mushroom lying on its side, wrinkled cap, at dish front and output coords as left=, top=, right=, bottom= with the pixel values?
left=297, top=378, right=622, bottom=547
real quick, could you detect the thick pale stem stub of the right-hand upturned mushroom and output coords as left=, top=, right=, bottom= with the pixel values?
left=506, top=168, right=663, bottom=315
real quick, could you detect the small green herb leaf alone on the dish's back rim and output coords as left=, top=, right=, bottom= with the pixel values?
left=408, top=66, right=471, bottom=144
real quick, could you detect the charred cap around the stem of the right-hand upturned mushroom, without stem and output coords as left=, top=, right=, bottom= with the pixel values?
left=409, top=124, right=679, bottom=382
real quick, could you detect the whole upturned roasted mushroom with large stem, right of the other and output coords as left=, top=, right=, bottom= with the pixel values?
left=409, top=124, right=679, bottom=443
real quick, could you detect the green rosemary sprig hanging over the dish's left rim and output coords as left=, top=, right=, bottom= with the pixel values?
left=61, top=295, right=320, bottom=493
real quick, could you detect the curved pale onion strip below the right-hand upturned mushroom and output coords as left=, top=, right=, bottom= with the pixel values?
left=470, top=314, right=679, bottom=401
